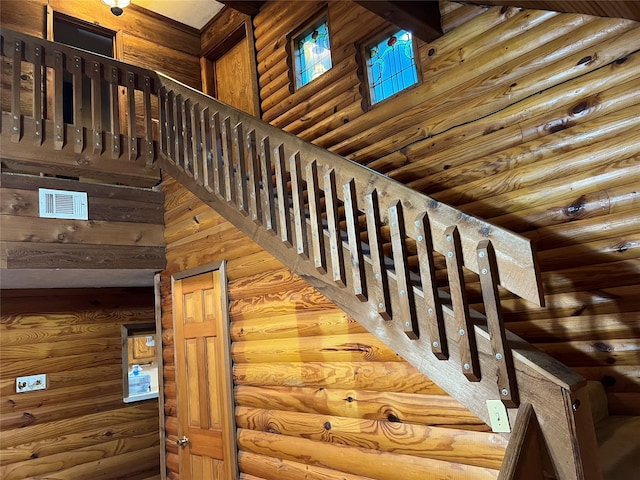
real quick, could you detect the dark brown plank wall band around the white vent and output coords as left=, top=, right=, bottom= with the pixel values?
left=0, top=173, right=165, bottom=275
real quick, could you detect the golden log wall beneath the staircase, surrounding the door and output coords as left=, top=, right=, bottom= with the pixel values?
left=162, top=179, right=506, bottom=480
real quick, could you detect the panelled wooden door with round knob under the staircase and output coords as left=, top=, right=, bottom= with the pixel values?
left=173, top=270, right=237, bottom=480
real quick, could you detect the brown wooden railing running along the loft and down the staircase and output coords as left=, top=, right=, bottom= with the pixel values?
left=0, top=30, right=600, bottom=479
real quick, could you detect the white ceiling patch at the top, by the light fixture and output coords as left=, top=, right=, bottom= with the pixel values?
left=131, top=0, right=224, bottom=30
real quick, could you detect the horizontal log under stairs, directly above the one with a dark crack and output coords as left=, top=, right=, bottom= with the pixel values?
left=231, top=311, right=366, bottom=342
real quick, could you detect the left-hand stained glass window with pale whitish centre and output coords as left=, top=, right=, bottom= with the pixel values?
left=293, top=18, right=331, bottom=88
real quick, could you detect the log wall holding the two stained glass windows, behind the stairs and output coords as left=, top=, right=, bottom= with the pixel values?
left=254, top=2, right=640, bottom=415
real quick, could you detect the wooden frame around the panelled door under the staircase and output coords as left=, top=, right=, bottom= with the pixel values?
left=171, top=260, right=240, bottom=480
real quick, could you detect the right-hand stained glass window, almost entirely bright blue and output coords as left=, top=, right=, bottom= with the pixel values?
left=366, top=30, right=418, bottom=105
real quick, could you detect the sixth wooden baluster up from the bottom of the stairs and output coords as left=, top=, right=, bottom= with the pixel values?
left=343, top=179, right=367, bottom=302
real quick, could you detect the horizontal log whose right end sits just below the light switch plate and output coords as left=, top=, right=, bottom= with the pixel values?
left=236, top=407, right=507, bottom=469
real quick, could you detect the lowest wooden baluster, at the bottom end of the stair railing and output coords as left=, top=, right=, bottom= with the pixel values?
left=477, top=240, right=520, bottom=408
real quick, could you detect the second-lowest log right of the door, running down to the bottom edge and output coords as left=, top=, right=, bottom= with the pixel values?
left=238, top=429, right=497, bottom=480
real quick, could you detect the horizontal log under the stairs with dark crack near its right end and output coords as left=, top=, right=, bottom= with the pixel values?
left=231, top=332, right=402, bottom=364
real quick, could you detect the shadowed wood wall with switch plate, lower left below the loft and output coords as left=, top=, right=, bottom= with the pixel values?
left=0, top=286, right=160, bottom=480
